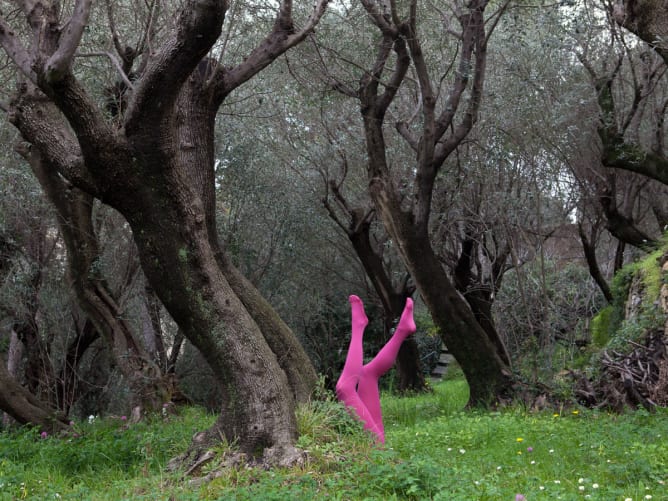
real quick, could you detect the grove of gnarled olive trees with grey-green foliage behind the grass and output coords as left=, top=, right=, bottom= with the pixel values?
left=0, top=0, right=668, bottom=464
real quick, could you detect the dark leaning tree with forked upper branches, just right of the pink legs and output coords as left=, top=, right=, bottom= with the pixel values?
left=349, top=0, right=512, bottom=405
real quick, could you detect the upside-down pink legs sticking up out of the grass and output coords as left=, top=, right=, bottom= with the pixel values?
left=336, top=296, right=415, bottom=443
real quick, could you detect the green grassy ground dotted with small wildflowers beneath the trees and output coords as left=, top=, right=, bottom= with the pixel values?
left=0, top=381, right=668, bottom=501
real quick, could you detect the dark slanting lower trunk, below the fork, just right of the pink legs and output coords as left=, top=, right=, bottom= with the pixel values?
left=370, top=178, right=511, bottom=406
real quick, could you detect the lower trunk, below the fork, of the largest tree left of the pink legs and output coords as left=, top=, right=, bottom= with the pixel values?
left=126, top=186, right=296, bottom=454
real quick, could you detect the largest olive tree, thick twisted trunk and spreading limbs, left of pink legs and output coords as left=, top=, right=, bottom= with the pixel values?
left=0, top=0, right=326, bottom=461
